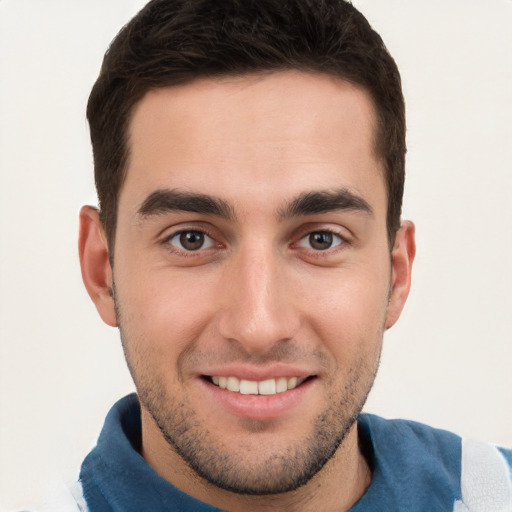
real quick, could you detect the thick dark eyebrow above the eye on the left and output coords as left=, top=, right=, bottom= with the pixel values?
left=137, top=189, right=235, bottom=220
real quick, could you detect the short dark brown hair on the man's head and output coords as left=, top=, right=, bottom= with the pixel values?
left=87, top=0, right=406, bottom=252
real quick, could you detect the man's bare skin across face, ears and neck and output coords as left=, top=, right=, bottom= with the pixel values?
left=80, top=71, right=415, bottom=511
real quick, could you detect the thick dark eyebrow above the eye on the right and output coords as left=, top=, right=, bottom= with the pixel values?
left=279, top=188, right=373, bottom=219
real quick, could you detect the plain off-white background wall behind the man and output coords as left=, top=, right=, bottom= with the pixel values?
left=0, top=0, right=512, bottom=511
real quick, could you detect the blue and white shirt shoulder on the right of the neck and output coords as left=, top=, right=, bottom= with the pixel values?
left=358, top=414, right=512, bottom=512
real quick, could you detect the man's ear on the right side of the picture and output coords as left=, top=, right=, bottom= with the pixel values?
left=386, top=221, right=416, bottom=329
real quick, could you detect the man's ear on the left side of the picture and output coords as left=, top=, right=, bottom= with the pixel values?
left=78, top=206, right=117, bottom=327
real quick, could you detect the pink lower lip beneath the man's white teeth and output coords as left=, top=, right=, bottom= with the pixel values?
left=202, top=379, right=316, bottom=420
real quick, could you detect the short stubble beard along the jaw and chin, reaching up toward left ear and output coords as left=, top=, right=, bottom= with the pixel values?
left=116, top=296, right=380, bottom=496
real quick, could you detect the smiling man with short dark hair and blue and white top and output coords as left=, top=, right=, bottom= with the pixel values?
left=74, top=0, right=512, bottom=511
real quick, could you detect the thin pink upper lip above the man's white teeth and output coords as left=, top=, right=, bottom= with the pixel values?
left=200, top=364, right=315, bottom=381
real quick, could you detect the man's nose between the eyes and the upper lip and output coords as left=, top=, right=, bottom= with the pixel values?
left=218, top=245, right=300, bottom=354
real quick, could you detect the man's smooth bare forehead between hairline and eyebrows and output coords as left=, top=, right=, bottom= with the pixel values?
left=120, top=71, right=385, bottom=216
